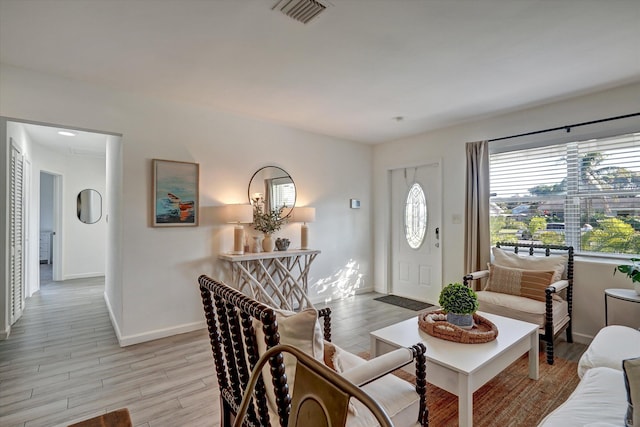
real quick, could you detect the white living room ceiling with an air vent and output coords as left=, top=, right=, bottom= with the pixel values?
left=0, top=0, right=640, bottom=143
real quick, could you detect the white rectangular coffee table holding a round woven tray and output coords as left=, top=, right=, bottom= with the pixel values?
left=370, top=312, right=539, bottom=427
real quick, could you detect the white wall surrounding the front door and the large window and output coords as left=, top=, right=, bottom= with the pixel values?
left=373, top=84, right=640, bottom=340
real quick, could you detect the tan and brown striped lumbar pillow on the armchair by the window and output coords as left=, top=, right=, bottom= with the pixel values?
left=484, top=264, right=555, bottom=301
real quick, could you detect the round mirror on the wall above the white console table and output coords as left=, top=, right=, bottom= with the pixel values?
left=248, top=166, right=296, bottom=218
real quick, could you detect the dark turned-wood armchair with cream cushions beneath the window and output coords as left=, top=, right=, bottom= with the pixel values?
left=463, top=242, right=573, bottom=365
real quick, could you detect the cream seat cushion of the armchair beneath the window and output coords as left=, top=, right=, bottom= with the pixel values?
left=476, top=291, right=569, bottom=333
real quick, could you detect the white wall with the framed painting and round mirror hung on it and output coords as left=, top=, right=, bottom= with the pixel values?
left=0, top=65, right=373, bottom=344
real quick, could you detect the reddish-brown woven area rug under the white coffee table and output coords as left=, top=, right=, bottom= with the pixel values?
left=359, top=352, right=580, bottom=427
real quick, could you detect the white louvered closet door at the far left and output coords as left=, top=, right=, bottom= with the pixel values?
left=9, top=144, right=25, bottom=325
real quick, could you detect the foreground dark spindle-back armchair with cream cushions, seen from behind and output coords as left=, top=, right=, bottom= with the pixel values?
left=198, top=275, right=428, bottom=427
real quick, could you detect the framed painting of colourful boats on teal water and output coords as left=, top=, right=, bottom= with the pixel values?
left=152, top=159, right=199, bottom=227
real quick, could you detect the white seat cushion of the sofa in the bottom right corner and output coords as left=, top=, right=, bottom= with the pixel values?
left=539, top=367, right=627, bottom=427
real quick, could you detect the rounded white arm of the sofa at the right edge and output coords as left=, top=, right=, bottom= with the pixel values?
left=578, top=325, right=640, bottom=378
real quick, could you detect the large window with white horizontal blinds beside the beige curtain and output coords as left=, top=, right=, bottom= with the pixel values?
left=490, top=133, right=640, bottom=255
